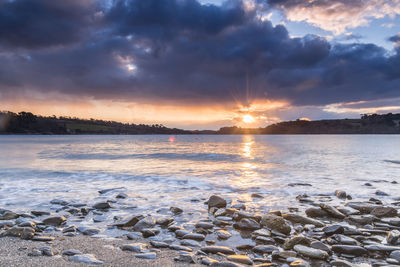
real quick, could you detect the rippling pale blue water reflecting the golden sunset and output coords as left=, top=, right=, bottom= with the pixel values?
left=0, top=135, right=400, bottom=237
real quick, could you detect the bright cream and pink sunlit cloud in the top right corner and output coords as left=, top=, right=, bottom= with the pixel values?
left=267, top=0, right=400, bottom=34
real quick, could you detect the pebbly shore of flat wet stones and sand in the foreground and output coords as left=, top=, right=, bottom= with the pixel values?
left=0, top=188, right=400, bottom=266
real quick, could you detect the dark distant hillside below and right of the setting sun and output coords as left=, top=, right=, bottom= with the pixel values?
left=217, top=113, right=400, bottom=134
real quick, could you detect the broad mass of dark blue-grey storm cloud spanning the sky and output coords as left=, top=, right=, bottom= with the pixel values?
left=0, top=0, right=400, bottom=109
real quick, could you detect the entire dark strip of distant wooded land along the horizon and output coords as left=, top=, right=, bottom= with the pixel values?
left=0, top=112, right=400, bottom=135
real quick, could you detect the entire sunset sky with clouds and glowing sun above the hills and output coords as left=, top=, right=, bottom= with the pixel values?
left=0, top=0, right=400, bottom=129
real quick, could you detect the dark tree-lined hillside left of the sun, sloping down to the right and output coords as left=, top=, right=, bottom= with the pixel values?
left=0, top=112, right=197, bottom=134
